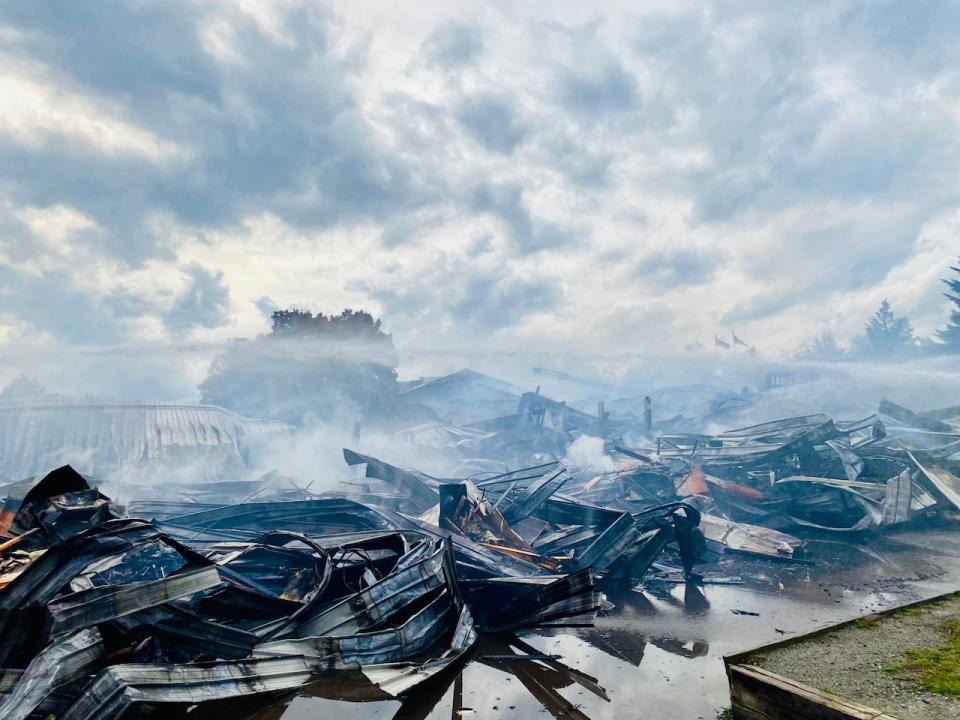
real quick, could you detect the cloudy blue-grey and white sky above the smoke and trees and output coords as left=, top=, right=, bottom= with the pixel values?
left=0, top=0, right=960, bottom=388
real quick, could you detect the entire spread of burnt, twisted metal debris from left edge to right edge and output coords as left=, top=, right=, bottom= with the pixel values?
left=0, top=386, right=960, bottom=720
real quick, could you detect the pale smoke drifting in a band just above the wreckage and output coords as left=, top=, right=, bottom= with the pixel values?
left=0, top=343, right=960, bottom=506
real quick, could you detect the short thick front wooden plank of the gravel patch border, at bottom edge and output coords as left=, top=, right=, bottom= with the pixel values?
left=729, top=665, right=896, bottom=720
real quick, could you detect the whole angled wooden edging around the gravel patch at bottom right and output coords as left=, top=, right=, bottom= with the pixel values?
left=723, top=591, right=960, bottom=720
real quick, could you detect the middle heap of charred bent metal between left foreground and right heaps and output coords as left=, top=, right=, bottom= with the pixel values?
left=343, top=449, right=806, bottom=564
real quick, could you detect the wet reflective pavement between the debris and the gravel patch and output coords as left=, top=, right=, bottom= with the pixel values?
left=197, top=526, right=960, bottom=720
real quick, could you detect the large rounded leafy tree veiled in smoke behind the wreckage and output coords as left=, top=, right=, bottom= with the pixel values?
left=200, top=309, right=397, bottom=425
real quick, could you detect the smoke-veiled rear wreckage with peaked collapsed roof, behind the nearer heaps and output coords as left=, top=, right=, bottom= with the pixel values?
left=394, top=368, right=756, bottom=475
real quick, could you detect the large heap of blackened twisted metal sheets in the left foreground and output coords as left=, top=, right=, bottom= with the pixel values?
left=0, top=466, right=612, bottom=720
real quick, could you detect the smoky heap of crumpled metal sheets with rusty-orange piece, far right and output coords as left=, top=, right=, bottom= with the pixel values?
left=620, top=401, right=960, bottom=538
